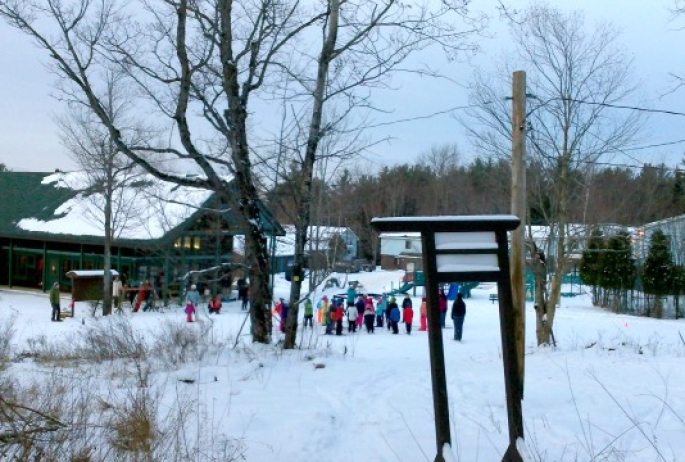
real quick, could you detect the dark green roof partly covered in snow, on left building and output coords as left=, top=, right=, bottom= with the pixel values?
left=0, top=172, right=284, bottom=249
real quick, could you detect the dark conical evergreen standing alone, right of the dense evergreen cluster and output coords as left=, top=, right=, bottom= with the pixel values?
left=642, top=229, right=673, bottom=317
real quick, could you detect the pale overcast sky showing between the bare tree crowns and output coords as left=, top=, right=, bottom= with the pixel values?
left=0, top=0, right=685, bottom=171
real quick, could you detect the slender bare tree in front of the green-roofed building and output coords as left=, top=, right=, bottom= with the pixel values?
left=57, top=72, right=152, bottom=316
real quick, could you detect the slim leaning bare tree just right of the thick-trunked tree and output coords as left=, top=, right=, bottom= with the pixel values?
left=252, top=0, right=481, bottom=348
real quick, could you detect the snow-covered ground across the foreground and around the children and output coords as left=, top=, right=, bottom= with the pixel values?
left=0, top=271, right=685, bottom=462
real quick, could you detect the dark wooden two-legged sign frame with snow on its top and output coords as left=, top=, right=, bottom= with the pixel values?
left=371, top=215, right=523, bottom=462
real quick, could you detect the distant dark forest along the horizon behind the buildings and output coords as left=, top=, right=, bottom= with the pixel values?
left=266, top=159, right=685, bottom=258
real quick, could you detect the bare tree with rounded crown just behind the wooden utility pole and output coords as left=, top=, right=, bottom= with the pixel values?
left=462, top=4, right=639, bottom=344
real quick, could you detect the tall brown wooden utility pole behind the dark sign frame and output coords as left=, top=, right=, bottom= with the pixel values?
left=511, top=71, right=526, bottom=399
